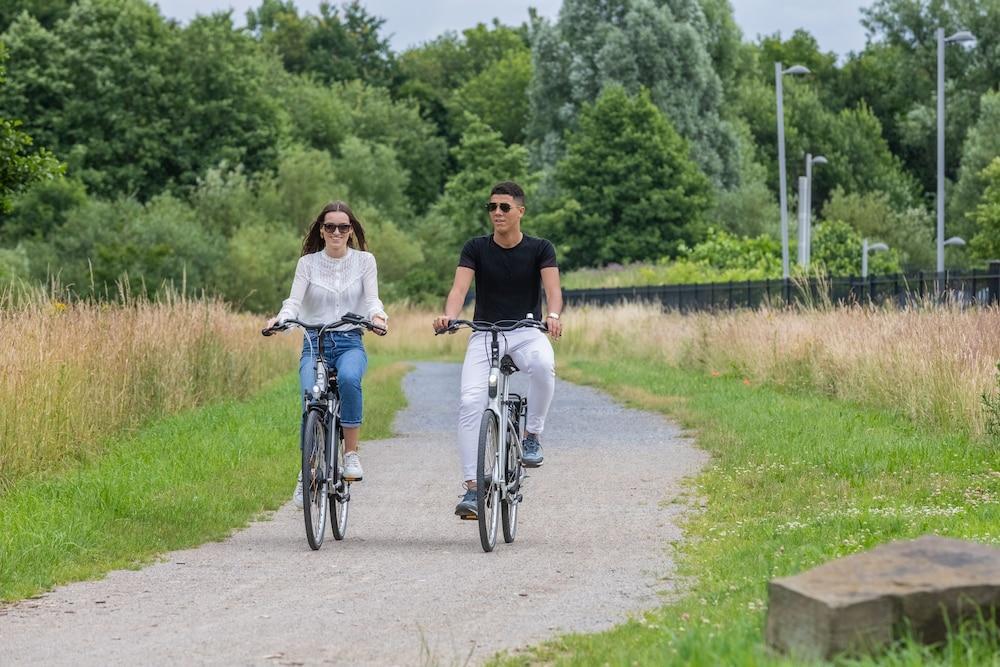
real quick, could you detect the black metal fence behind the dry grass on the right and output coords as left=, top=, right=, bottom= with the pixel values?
left=563, top=261, right=1000, bottom=312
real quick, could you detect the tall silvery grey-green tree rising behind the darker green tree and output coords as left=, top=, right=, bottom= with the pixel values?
left=528, top=0, right=739, bottom=187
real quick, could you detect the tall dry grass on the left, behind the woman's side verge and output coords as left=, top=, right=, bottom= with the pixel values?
left=0, top=290, right=299, bottom=492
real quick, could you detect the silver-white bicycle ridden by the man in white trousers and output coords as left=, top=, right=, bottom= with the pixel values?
left=436, top=314, right=548, bottom=553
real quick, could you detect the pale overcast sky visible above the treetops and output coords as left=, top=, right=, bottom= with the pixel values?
left=157, top=0, right=873, bottom=56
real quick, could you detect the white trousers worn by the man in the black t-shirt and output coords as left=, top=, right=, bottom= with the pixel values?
left=458, top=329, right=556, bottom=480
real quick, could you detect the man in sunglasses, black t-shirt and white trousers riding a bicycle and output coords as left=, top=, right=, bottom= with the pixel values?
left=434, top=181, right=563, bottom=518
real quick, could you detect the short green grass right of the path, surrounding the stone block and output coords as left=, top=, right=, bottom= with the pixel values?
left=501, top=359, right=1000, bottom=665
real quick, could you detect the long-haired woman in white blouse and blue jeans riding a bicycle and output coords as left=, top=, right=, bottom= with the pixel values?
left=267, top=201, right=389, bottom=507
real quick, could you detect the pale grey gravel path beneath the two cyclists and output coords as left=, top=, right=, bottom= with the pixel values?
left=0, top=363, right=706, bottom=665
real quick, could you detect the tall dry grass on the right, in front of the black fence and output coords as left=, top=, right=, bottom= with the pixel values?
left=561, top=305, right=1000, bottom=436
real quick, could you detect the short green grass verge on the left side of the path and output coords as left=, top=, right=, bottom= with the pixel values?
left=0, top=356, right=406, bottom=601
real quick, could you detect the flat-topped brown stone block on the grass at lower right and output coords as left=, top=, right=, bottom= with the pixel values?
left=766, top=535, right=1000, bottom=659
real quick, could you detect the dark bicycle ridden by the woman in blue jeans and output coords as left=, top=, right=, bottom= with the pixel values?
left=261, top=313, right=385, bottom=550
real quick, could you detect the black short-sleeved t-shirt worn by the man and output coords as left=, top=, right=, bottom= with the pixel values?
left=458, top=234, right=559, bottom=322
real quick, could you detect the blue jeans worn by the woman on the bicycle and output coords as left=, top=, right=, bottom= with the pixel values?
left=299, top=330, right=368, bottom=428
